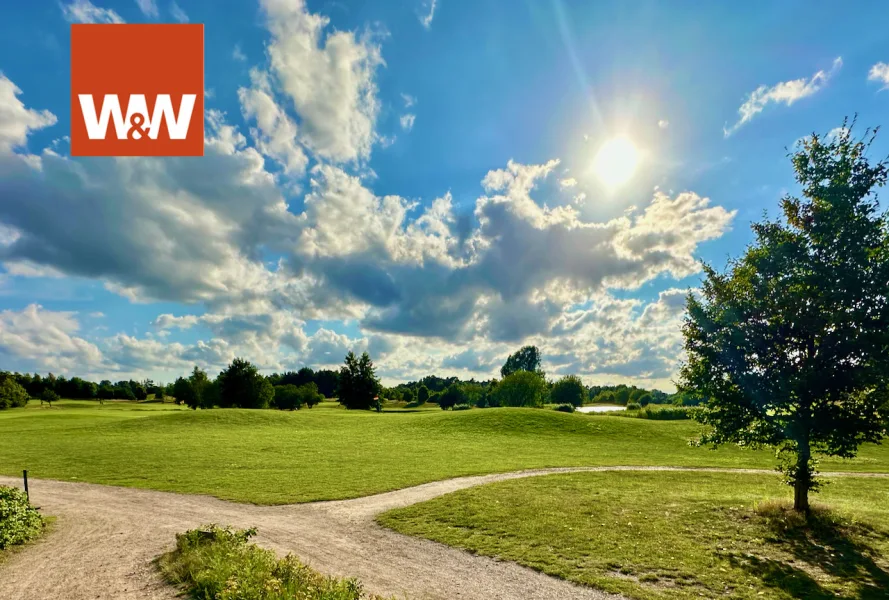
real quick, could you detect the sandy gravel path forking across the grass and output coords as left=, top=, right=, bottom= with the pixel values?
left=0, top=467, right=889, bottom=600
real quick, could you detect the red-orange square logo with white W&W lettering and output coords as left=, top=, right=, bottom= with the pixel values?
left=71, top=24, right=204, bottom=156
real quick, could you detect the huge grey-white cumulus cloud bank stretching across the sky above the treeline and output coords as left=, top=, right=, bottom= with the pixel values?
left=0, top=69, right=734, bottom=379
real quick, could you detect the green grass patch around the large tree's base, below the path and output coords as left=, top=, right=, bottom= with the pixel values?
left=379, top=474, right=889, bottom=600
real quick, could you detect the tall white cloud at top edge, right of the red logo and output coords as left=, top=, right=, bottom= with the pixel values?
left=262, top=0, right=383, bottom=162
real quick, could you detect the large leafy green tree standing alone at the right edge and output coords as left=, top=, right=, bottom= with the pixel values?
left=680, top=127, right=889, bottom=511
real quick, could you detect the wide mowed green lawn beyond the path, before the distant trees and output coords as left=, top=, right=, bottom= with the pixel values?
left=0, top=401, right=889, bottom=504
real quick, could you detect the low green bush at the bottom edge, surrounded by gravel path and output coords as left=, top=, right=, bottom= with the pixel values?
left=159, top=525, right=381, bottom=600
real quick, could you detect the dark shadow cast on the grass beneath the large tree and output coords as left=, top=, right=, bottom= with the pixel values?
left=730, top=504, right=889, bottom=600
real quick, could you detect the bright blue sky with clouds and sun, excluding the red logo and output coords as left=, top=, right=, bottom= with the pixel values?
left=0, top=0, right=889, bottom=390
